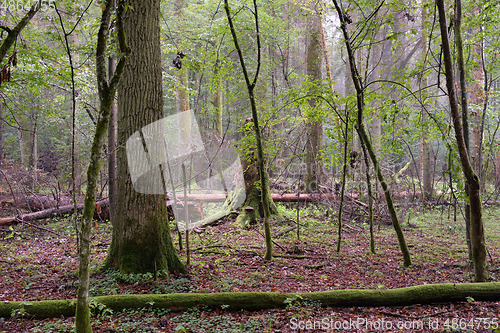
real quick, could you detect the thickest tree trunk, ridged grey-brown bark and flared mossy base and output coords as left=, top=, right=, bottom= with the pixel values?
left=106, top=0, right=185, bottom=273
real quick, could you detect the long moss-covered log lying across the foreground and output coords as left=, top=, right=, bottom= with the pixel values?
left=0, top=282, right=500, bottom=318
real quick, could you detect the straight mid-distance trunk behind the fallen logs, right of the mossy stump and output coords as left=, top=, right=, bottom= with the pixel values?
left=305, top=4, right=323, bottom=193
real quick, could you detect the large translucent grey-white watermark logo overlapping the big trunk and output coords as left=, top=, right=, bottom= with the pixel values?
left=126, top=111, right=245, bottom=231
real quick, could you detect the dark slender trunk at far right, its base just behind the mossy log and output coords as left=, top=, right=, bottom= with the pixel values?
left=436, top=0, right=487, bottom=282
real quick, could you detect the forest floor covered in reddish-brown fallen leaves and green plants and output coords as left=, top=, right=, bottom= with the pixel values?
left=0, top=200, right=500, bottom=333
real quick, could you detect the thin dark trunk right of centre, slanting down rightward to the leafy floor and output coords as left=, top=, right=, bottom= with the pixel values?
left=333, top=0, right=411, bottom=266
